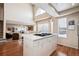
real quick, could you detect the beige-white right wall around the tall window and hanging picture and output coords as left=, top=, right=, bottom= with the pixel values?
left=54, top=12, right=79, bottom=49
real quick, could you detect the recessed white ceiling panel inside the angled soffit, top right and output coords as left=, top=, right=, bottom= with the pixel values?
left=51, top=3, right=79, bottom=12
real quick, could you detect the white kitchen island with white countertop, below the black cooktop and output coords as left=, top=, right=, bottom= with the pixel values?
left=23, top=34, right=57, bottom=56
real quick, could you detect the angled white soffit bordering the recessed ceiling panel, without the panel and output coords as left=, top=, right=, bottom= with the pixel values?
left=34, top=3, right=79, bottom=17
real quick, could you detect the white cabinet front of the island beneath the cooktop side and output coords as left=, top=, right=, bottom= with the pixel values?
left=33, top=36, right=57, bottom=56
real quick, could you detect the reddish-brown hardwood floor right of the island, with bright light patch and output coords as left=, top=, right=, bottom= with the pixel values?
left=51, top=45, right=79, bottom=56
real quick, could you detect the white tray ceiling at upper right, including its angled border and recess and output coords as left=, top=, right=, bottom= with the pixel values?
left=34, top=3, right=79, bottom=17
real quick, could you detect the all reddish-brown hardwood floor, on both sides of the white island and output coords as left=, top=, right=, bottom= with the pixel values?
left=0, top=40, right=79, bottom=56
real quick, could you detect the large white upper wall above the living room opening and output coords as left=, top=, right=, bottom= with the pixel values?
left=4, top=3, right=33, bottom=25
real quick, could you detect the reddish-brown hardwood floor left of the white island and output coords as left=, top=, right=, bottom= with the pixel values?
left=0, top=40, right=23, bottom=56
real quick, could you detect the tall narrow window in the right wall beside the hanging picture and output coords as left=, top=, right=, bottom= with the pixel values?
left=58, top=18, right=67, bottom=38
